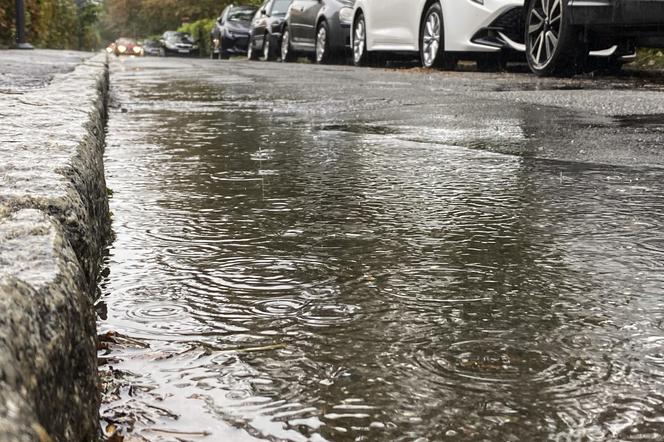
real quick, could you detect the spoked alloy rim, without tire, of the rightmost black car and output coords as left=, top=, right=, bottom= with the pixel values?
left=526, top=0, right=563, bottom=68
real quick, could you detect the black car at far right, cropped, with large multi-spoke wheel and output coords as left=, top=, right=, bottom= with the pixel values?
left=525, top=0, right=664, bottom=76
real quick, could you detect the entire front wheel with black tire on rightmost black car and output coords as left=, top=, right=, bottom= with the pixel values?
left=525, top=0, right=588, bottom=77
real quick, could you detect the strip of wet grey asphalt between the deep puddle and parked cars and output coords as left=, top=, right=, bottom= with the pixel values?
left=113, top=58, right=664, bottom=166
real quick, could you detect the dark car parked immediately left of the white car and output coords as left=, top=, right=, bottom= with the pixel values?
left=281, top=0, right=353, bottom=64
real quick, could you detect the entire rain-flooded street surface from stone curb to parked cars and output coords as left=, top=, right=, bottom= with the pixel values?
left=98, top=59, right=664, bottom=441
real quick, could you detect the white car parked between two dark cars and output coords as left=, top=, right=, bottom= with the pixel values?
left=351, top=0, right=525, bottom=67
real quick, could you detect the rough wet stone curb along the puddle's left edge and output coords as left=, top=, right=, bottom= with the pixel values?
left=0, top=54, right=110, bottom=441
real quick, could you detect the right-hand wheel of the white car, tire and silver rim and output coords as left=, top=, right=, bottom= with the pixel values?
left=420, top=2, right=456, bottom=68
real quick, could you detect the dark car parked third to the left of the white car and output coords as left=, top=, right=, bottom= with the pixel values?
left=211, top=5, right=258, bottom=59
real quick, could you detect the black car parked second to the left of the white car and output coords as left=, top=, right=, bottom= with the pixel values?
left=247, top=0, right=292, bottom=61
